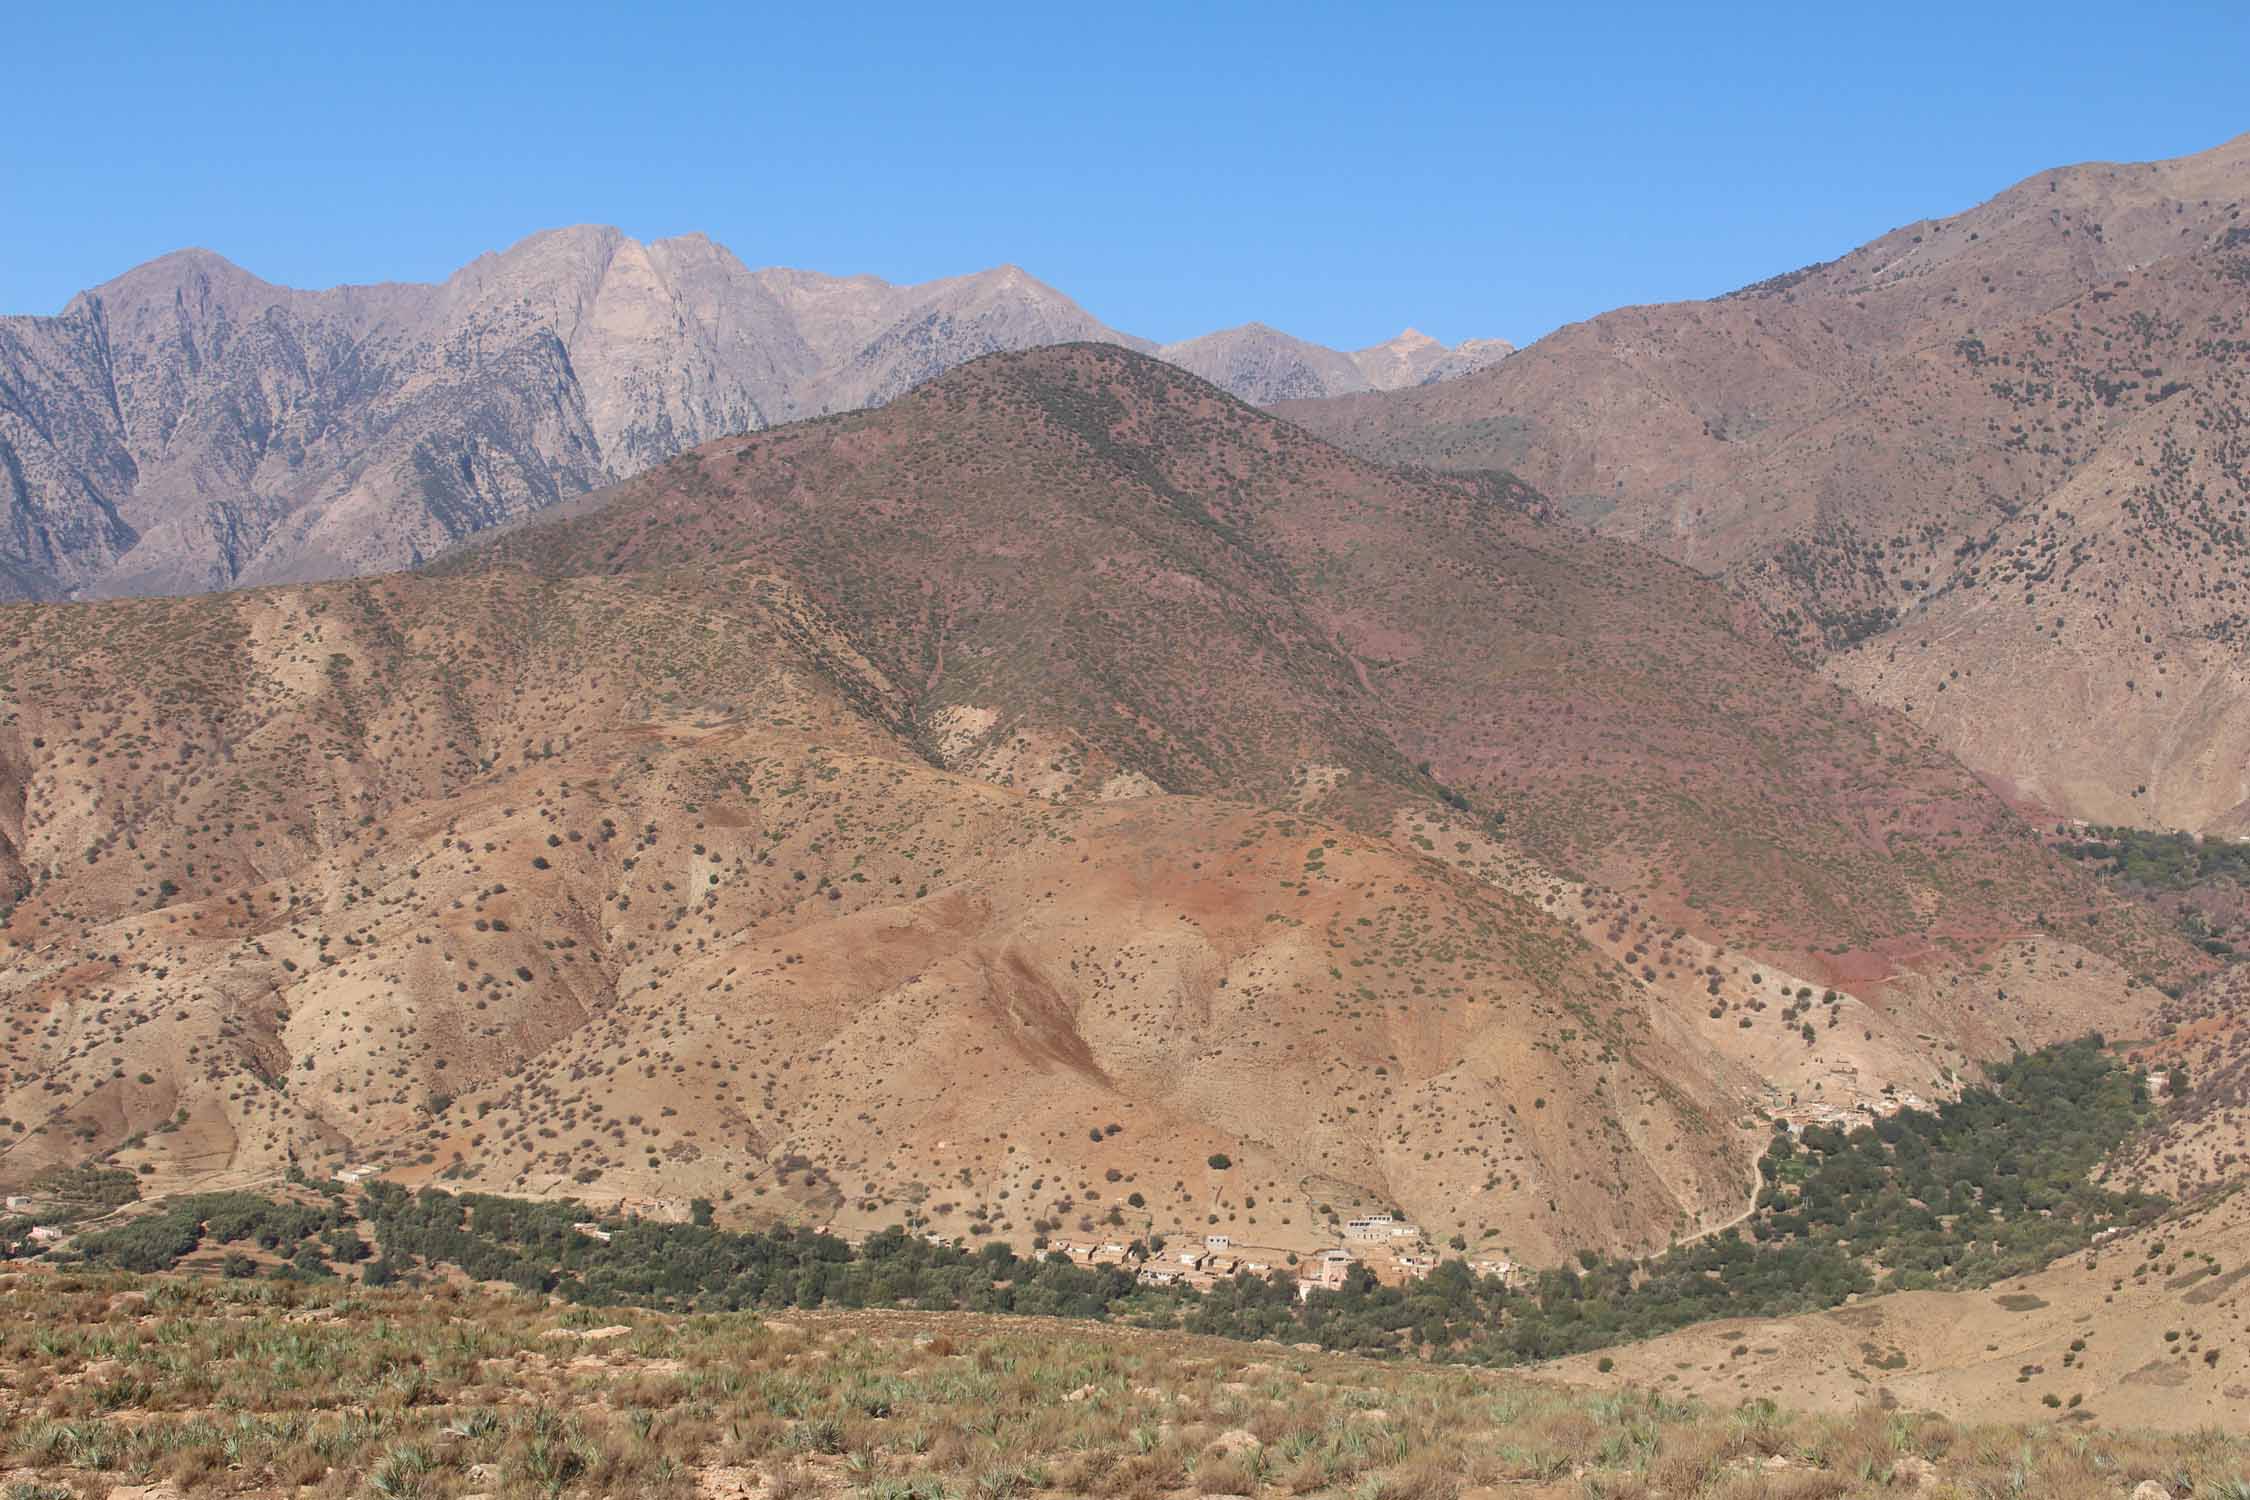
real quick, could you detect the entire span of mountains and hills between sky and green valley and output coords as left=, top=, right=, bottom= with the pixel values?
left=0, top=137, right=2250, bottom=1295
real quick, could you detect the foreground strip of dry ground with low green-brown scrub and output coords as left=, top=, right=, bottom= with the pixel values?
left=0, top=1273, right=2250, bottom=1500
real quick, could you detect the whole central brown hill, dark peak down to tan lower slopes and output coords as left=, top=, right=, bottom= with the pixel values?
left=0, top=346, right=2198, bottom=1259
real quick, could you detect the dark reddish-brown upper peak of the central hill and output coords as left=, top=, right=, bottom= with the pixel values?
left=450, top=346, right=2196, bottom=976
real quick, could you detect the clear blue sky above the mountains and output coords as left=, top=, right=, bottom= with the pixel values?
left=0, top=0, right=2250, bottom=346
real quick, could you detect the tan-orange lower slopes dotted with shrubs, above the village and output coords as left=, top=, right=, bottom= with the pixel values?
left=0, top=571, right=1742, bottom=1255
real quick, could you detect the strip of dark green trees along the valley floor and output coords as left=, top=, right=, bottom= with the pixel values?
left=48, top=1037, right=2162, bottom=1365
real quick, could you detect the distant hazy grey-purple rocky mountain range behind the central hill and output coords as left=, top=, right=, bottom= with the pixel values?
left=0, top=227, right=1510, bottom=598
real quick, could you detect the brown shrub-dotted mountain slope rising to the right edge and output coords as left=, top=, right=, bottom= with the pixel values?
left=1280, top=135, right=2250, bottom=837
